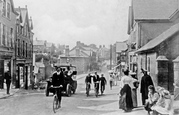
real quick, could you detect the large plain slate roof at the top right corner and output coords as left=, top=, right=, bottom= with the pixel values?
left=132, top=0, right=178, bottom=20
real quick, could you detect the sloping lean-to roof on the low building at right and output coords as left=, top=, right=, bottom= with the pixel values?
left=135, top=24, right=179, bottom=53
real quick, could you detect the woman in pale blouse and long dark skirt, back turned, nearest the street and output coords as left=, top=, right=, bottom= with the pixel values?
left=119, top=69, right=134, bottom=112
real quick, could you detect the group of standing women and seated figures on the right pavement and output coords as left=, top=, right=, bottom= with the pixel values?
left=119, top=69, right=173, bottom=115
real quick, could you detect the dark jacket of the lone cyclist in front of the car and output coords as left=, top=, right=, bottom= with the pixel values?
left=52, top=72, right=64, bottom=86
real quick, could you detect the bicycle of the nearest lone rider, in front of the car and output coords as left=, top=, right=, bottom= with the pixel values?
left=52, top=86, right=62, bottom=113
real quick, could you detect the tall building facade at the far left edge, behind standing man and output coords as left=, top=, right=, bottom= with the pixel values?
left=0, top=0, right=18, bottom=88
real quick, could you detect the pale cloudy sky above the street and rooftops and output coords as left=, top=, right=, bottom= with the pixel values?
left=14, top=0, right=131, bottom=48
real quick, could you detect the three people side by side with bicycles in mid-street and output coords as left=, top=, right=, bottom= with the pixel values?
left=85, top=72, right=107, bottom=94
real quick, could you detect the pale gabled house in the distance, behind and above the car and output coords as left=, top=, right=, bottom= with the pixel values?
left=59, top=41, right=97, bottom=73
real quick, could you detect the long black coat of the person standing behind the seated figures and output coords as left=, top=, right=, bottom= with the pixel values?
left=140, top=75, right=154, bottom=99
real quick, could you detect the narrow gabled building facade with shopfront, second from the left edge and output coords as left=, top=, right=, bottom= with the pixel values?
left=15, top=6, right=33, bottom=89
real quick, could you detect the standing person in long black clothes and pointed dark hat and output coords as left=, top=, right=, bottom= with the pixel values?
left=140, top=69, right=153, bottom=105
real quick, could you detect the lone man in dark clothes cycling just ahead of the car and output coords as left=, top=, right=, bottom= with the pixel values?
left=52, top=67, right=64, bottom=107
